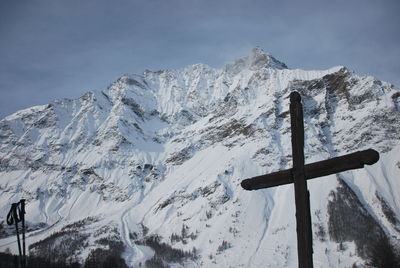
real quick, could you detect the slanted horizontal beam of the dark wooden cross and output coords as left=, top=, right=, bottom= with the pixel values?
left=241, top=149, right=379, bottom=190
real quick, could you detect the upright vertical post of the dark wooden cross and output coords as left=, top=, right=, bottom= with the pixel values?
left=290, top=92, right=313, bottom=268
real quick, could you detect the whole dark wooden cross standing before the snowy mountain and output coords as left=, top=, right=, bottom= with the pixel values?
left=241, top=91, right=379, bottom=268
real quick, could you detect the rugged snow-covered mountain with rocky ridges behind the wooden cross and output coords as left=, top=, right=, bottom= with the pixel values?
left=0, top=49, right=400, bottom=267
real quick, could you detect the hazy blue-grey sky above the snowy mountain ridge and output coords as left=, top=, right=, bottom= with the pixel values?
left=0, top=0, right=400, bottom=118
